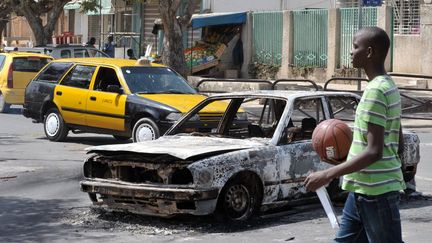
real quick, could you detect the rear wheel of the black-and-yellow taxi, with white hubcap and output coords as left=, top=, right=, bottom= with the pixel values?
left=44, top=108, right=69, bottom=142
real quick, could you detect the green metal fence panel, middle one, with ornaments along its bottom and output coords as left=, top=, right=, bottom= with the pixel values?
left=293, top=10, right=328, bottom=67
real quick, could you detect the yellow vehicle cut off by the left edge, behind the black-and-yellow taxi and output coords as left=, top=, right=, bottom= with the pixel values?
left=0, top=52, right=53, bottom=113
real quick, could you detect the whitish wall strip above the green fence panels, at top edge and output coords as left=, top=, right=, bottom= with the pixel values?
left=203, top=0, right=335, bottom=13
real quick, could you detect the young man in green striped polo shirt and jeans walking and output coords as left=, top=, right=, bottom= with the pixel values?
left=305, top=27, right=405, bottom=243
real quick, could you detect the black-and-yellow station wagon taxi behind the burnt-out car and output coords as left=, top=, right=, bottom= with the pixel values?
left=23, top=58, right=227, bottom=142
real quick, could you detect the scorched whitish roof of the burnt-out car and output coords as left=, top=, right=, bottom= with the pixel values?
left=209, top=90, right=360, bottom=99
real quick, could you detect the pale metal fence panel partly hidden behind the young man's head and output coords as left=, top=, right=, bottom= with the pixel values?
left=338, top=7, right=377, bottom=68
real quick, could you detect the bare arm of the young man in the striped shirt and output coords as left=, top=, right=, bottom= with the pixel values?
left=305, top=123, right=385, bottom=191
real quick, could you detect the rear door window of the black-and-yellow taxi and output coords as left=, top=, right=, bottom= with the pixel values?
left=60, top=65, right=96, bottom=89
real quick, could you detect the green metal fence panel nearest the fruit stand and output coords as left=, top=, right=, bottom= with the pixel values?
left=252, top=11, right=283, bottom=66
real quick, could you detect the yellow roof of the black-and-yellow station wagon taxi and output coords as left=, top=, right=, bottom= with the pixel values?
left=50, top=57, right=165, bottom=67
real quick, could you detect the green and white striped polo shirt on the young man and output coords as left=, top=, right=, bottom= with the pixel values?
left=342, top=75, right=405, bottom=195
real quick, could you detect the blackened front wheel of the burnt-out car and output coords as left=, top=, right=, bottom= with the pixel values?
left=216, top=177, right=259, bottom=222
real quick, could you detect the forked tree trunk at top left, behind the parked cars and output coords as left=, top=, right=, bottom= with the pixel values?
left=7, top=0, right=70, bottom=45
